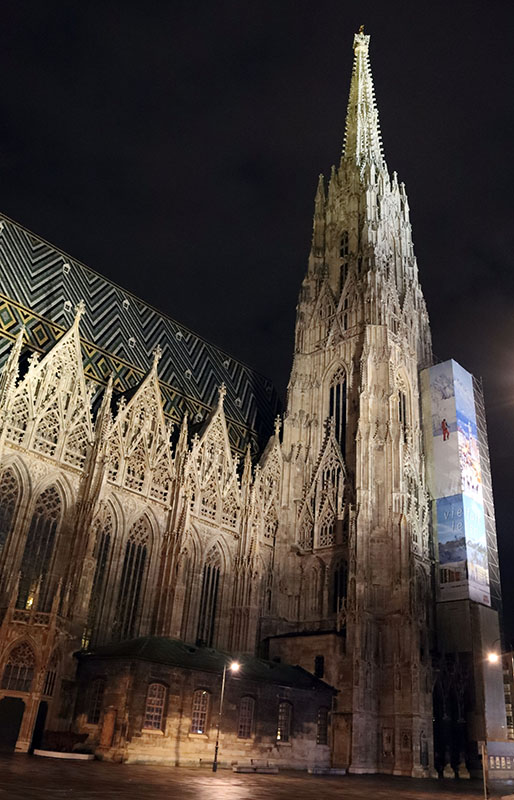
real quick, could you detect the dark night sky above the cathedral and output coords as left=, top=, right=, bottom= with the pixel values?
left=0, top=0, right=514, bottom=636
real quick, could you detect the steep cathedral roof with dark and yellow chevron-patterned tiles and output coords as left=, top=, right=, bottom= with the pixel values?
left=0, top=215, right=280, bottom=451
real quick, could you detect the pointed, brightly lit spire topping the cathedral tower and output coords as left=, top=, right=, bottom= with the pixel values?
left=343, top=25, right=385, bottom=167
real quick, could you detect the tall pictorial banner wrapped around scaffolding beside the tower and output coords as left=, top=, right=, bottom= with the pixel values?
left=421, top=360, right=491, bottom=605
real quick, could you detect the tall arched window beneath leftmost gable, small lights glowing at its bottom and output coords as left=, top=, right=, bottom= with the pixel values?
left=18, top=486, right=61, bottom=610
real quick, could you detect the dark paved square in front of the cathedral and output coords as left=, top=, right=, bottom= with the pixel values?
left=0, top=755, right=514, bottom=800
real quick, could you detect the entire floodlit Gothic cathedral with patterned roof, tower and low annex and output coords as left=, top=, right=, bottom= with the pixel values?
left=0, top=31, right=505, bottom=777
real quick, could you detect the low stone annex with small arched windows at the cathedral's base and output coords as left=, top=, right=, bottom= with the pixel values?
left=75, top=637, right=335, bottom=769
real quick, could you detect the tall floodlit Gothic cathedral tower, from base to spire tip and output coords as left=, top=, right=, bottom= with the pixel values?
left=263, top=29, right=433, bottom=775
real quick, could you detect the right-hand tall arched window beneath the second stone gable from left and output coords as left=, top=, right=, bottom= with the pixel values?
left=115, top=517, right=150, bottom=639
